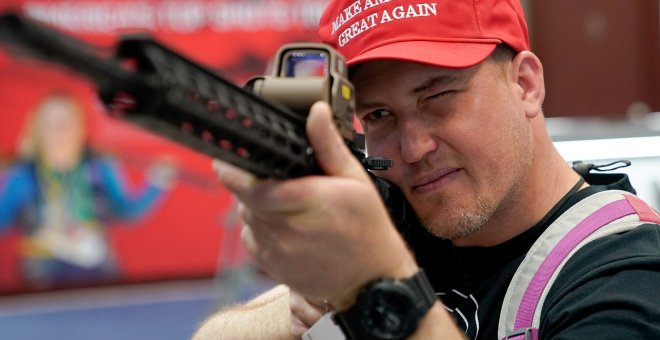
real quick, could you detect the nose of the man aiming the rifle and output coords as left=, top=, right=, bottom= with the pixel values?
left=400, top=120, right=438, bottom=164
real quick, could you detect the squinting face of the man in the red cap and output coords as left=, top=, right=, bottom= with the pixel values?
left=353, top=60, right=533, bottom=240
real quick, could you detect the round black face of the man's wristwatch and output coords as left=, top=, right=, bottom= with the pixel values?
left=359, top=284, right=417, bottom=339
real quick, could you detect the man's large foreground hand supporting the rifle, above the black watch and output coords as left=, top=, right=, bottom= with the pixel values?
left=214, top=103, right=417, bottom=310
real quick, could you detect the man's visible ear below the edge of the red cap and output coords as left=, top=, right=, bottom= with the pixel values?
left=511, top=51, right=545, bottom=118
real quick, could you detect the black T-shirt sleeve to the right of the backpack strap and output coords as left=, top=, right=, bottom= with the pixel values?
left=539, top=224, right=660, bottom=339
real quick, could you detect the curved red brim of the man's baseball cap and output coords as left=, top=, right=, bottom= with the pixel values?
left=347, top=41, right=498, bottom=68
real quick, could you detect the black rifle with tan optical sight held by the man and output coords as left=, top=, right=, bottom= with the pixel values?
left=0, top=13, right=409, bottom=225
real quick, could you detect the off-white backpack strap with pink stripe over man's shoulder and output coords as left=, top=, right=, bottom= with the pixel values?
left=497, top=190, right=660, bottom=339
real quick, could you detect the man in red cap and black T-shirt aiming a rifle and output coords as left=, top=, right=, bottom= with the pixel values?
left=197, top=0, right=660, bottom=339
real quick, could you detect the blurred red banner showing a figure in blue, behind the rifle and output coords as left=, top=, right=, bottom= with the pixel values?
left=0, top=0, right=325, bottom=293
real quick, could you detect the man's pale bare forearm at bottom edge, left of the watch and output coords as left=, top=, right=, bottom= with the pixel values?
left=193, top=285, right=292, bottom=340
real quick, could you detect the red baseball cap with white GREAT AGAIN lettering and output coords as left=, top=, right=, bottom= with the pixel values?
left=318, top=0, right=530, bottom=68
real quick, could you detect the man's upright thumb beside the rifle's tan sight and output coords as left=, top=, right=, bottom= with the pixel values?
left=307, top=102, right=367, bottom=179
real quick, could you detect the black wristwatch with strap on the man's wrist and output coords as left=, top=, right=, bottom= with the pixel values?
left=334, top=269, right=436, bottom=340
